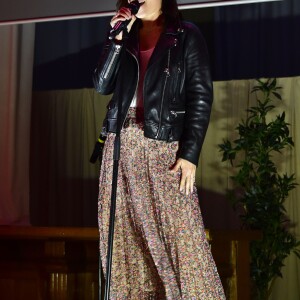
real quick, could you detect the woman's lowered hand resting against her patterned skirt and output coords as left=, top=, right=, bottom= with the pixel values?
left=171, top=158, right=196, bottom=195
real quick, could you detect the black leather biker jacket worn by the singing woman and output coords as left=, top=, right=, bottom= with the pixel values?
left=94, top=20, right=212, bottom=165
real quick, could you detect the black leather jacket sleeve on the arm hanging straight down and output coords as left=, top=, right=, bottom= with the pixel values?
left=179, top=24, right=213, bottom=165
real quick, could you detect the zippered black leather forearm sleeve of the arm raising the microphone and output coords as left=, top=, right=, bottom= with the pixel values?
left=93, top=40, right=123, bottom=95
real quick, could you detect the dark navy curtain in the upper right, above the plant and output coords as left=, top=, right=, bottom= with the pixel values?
left=213, top=0, right=300, bottom=80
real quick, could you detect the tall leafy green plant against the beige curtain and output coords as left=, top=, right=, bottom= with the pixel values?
left=219, top=79, right=300, bottom=300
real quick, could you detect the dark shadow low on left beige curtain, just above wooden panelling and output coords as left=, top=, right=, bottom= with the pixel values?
left=30, top=178, right=98, bottom=227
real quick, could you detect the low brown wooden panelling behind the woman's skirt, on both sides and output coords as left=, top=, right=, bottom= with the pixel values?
left=0, top=226, right=259, bottom=300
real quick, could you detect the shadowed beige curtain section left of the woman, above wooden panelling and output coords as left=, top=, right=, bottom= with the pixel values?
left=30, top=89, right=105, bottom=226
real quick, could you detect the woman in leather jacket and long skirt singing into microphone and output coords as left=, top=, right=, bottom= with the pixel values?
left=94, top=0, right=225, bottom=300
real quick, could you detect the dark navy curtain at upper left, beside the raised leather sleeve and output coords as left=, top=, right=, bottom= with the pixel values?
left=33, top=17, right=110, bottom=91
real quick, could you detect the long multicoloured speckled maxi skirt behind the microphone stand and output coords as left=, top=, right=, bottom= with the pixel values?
left=98, top=109, right=225, bottom=300
